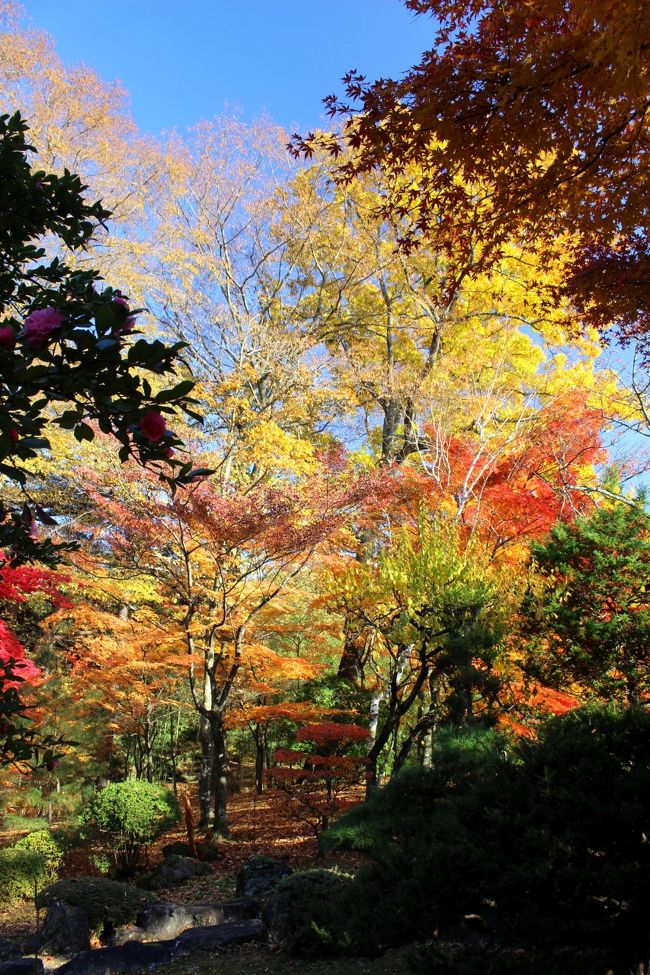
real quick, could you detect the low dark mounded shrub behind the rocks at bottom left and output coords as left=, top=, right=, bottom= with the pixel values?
left=36, top=877, right=153, bottom=934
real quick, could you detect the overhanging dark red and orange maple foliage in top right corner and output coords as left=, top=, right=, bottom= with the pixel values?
left=293, top=0, right=650, bottom=352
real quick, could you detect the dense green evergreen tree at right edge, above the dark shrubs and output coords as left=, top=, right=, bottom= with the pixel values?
left=525, top=498, right=650, bottom=704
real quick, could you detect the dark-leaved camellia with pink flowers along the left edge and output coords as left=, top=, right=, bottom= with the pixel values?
left=0, top=113, right=205, bottom=764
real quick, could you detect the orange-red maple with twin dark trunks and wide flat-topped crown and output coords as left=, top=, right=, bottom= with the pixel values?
left=76, top=471, right=390, bottom=829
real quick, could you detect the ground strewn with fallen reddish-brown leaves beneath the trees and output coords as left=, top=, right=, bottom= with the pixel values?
left=0, top=787, right=410, bottom=975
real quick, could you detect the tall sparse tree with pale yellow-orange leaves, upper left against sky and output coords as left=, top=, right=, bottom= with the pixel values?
left=0, top=9, right=339, bottom=484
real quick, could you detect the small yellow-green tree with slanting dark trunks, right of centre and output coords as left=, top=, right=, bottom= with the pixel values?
left=330, top=512, right=515, bottom=788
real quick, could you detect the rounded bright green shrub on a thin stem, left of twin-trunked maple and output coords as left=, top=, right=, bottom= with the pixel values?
left=80, top=780, right=180, bottom=876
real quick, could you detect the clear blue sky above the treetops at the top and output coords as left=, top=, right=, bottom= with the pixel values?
left=23, top=0, right=433, bottom=132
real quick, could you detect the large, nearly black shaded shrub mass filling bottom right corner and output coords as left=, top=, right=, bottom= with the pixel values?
left=314, top=707, right=650, bottom=975
